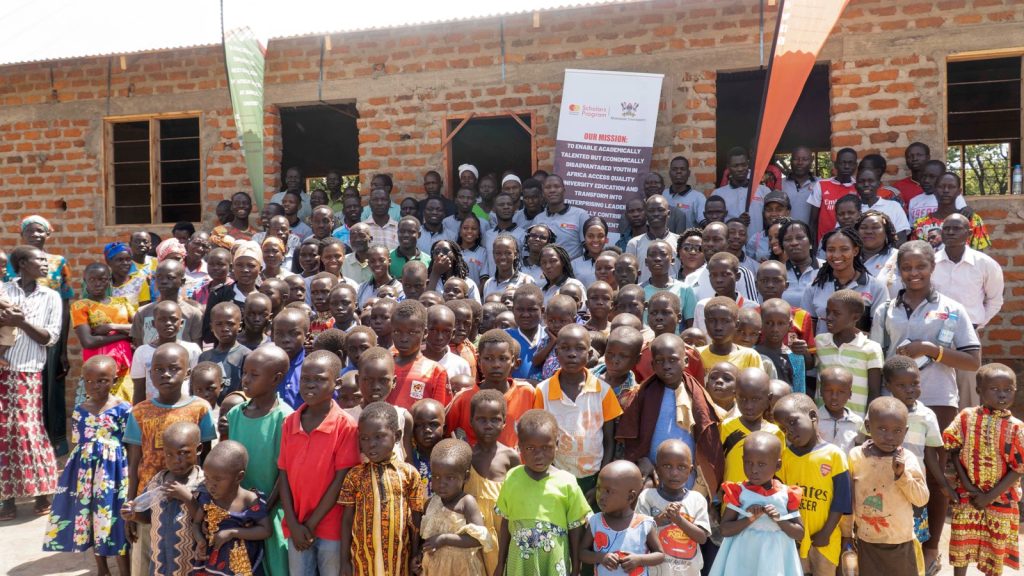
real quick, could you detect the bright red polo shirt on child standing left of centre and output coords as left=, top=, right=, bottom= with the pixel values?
left=278, top=402, right=359, bottom=540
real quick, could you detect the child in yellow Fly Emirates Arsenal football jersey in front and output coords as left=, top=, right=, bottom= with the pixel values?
left=770, top=394, right=852, bottom=576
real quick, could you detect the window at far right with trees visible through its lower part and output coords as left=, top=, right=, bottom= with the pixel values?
left=946, top=56, right=1021, bottom=195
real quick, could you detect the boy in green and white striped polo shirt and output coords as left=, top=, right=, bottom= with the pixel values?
left=814, top=290, right=885, bottom=417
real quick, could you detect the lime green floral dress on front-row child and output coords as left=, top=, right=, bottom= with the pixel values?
left=496, top=466, right=590, bottom=576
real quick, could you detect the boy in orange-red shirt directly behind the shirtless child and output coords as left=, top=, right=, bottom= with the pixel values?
left=444, top=329, right=535, bottom=448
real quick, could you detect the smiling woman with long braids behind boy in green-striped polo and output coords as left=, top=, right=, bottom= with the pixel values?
left=800, top=228, right=889, bottom=334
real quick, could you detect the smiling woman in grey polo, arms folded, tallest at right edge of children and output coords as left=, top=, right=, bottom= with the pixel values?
left=871, top=237, right=978, bottom=573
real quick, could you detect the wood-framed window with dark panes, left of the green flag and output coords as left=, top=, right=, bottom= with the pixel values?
left=106, top=117, right=203, bottom=224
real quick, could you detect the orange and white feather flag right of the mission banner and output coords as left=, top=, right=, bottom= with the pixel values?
left=746, top=0, right=849, bottom=208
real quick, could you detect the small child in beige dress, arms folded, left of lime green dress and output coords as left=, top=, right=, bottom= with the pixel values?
left=420, top=438, right=497, bottom=576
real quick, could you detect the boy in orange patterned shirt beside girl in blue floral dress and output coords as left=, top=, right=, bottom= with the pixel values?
left=123, top=342, right=217, bottom=574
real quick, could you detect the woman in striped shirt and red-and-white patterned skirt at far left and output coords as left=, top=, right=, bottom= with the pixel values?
left=0, top=246, right=63, bottom=521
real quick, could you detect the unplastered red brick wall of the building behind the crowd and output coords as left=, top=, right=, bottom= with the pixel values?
left=0, top=0, right=1024, bottom=403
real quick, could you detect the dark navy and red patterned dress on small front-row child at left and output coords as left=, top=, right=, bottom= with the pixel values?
left=193, top=486, right=268, bottom=576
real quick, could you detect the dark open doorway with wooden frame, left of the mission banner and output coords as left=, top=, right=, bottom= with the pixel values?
left=445, top=113, right=537, bottom=192
